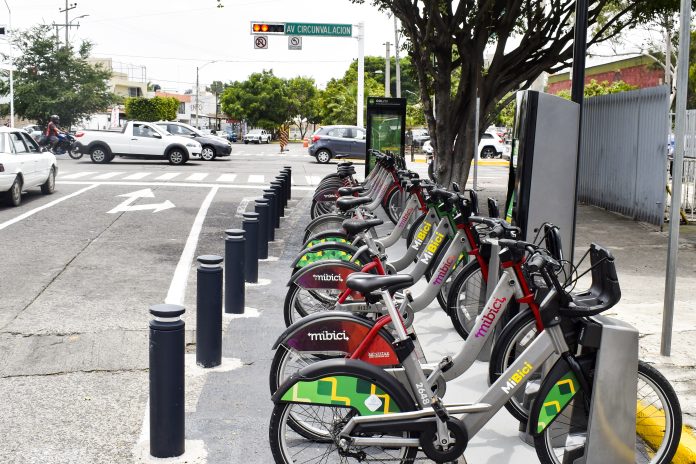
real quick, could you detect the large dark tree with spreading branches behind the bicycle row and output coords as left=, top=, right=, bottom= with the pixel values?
left=351, top=0, right=692, bottom=185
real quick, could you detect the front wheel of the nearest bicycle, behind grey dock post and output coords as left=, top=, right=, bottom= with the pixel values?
left=534, top=361, right=682, bottom=464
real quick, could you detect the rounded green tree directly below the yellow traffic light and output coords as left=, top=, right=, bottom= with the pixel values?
left=220, top=71, right=292, bottom=130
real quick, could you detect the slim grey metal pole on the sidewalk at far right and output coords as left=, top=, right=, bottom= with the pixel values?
left=660, top=0, right=691, bottom=356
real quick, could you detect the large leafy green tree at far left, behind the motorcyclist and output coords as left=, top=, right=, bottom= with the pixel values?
left=0, top=25, right=116, bottom=127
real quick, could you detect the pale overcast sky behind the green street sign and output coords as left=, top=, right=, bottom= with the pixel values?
left=0, top=0, right=394, bottom=91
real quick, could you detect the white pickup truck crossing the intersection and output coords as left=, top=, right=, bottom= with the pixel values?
left=75, top=121, right=201, bottom=165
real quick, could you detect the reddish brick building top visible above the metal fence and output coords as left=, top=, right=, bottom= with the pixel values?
left=547, top=55, right=665, bottom=94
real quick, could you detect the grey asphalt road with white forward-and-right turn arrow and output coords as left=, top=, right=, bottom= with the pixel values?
left=0, top=144, right=502, bottom=463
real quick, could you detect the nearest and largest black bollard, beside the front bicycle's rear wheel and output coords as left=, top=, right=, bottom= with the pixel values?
left=150, top=304, right=186, bottom=458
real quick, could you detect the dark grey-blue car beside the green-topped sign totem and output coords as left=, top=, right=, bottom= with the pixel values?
left=309, top=126, right=365, bottom=164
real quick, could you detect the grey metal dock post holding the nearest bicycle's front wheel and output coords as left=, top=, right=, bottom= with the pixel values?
left=585, top=316, right=638, bottom=464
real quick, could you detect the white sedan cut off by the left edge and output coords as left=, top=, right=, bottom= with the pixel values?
left=0, top=127, right=58, bottom=206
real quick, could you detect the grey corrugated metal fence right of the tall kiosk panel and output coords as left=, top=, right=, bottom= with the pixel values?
left=578, top=86, right=669, bottom=225
